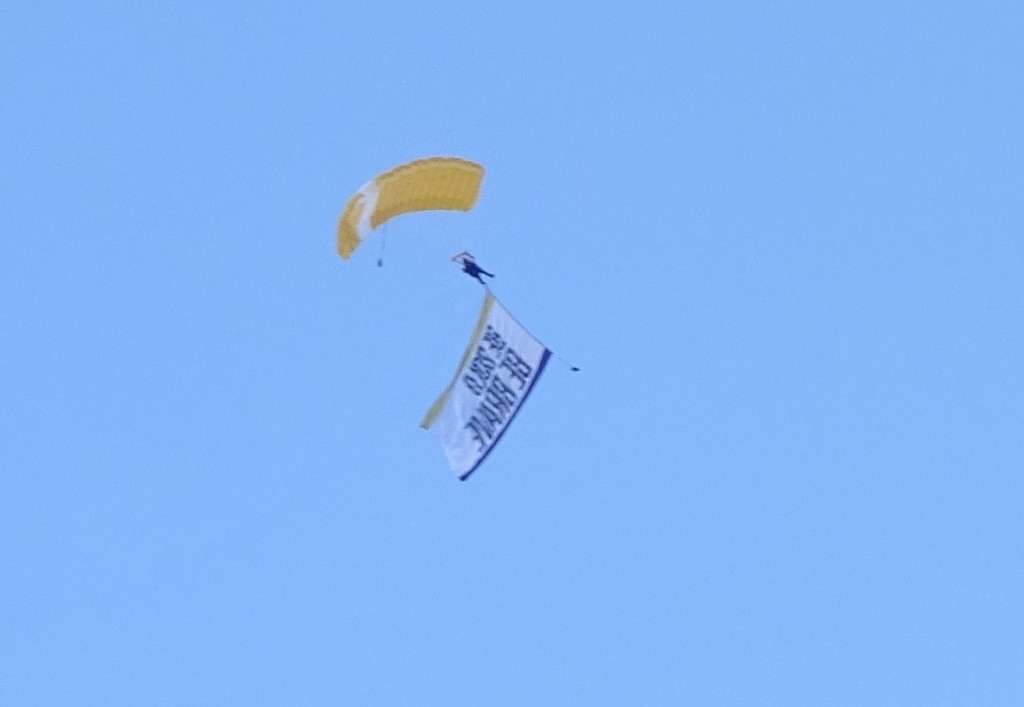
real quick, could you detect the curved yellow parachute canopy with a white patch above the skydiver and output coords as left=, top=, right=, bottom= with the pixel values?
left=338, top=157, right=483, bottom=260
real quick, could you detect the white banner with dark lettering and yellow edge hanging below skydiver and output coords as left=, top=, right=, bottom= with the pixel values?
left=420, top=292, right=551, bottom=481
